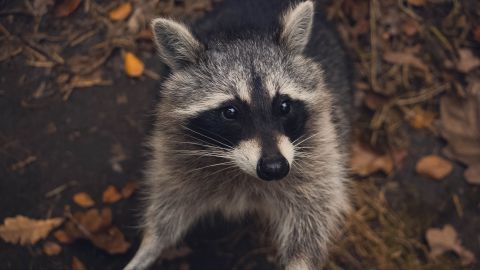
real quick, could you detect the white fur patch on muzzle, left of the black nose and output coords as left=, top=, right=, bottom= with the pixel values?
left=232, top=139, right=261, bottom=177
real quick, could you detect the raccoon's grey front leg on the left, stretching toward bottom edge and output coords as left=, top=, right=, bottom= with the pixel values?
left=124, top=198, right=202, bottom=270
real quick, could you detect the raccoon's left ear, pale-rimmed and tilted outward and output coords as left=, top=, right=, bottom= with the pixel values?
left=151, top=18, right=204, bottom=69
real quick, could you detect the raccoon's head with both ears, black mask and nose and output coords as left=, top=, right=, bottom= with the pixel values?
left=152, top=1, right=327, bottom=181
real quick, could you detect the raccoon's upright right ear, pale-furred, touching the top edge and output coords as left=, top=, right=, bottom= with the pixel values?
left=280, top=1, right=315, bottom=54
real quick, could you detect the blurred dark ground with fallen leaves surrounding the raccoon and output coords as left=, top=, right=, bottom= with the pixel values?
left=0, top=0, right=480, bottom=270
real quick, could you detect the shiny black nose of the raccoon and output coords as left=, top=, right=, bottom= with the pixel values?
left=257, top=156, right=290, bottom=181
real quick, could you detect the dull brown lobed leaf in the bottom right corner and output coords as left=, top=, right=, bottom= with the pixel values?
left=426, top=224, right=475, bottom=266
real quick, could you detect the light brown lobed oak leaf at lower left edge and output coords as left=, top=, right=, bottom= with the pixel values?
left=0, top=215, right=63, bottom=246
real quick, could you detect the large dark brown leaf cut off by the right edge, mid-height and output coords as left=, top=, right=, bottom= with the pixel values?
left=440, top=92, right=480, bottom=184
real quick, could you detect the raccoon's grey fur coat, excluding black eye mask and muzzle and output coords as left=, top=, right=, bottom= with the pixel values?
left=125, top=1, right=350, bottom=270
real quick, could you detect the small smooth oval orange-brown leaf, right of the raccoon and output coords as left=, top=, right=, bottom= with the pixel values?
left=415, top=155, right=453, bottom=180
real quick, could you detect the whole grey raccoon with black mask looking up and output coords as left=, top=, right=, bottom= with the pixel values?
left=125, top=0, right=352, bottom=270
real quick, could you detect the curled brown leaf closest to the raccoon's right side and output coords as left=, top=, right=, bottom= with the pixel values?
left=351, top=143, right=393, bottom=176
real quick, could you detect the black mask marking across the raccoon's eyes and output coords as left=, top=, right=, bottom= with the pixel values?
left=187, top=95, right=309, bottom=148
